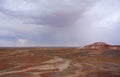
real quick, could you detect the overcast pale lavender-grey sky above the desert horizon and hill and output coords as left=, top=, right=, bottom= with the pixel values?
left=0, top=0, right=120, bottom=47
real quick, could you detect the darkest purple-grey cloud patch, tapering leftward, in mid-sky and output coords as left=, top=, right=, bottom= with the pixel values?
left=28, top=12, right=80, bottom=27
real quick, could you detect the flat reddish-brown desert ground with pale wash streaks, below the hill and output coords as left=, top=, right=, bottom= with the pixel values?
left=0, top=43, right=120, bottom=77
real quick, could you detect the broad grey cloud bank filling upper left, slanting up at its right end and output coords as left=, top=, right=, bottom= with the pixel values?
left=0, top=0, right=93, bottom=26
